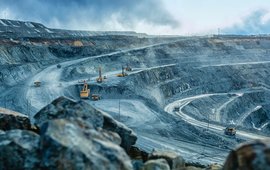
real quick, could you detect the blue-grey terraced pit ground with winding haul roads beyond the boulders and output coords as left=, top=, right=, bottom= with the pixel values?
left=0, top=19, right=270, bottom=163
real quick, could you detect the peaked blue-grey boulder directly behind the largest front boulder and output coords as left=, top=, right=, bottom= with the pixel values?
left=34, top=96, right=103, bottom=128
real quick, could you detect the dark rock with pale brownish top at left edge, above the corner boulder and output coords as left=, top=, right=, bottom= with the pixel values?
left=0, top=108, right=31, bottom=131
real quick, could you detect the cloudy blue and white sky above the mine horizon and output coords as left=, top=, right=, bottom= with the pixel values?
left=0, top=0, right=270, bottom=35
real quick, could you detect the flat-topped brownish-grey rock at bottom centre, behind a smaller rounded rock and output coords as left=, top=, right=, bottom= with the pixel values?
left=149, top=151, right=185, bottom=170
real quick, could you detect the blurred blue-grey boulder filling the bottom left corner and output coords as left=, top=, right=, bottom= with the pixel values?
left=0, top=130, right=40, bottom=170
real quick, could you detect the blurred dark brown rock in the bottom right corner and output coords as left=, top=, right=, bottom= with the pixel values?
left=224, top=140, right=270, bottom=170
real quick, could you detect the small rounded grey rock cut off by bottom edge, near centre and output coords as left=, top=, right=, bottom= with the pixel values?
left=143, top=159, right=170, bottom=170
